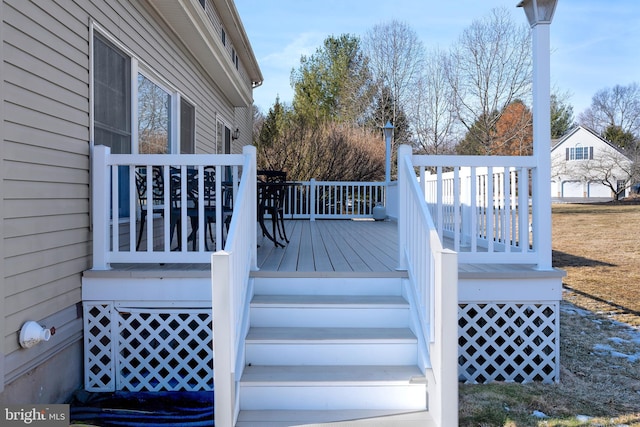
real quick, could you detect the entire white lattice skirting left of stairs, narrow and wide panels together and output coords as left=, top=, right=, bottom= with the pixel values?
left=84, top=302, right=213, bottom=391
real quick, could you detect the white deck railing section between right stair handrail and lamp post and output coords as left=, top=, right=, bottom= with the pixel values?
left=413, top=156, right=540, bottom=264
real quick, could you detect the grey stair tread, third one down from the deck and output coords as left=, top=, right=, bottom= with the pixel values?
left=240, top=365, right=425, bottom=386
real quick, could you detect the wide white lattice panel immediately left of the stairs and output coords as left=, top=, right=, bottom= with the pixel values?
left=116, top=309, right=213, bottom=391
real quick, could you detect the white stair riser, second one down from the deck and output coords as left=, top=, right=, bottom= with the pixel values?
left=251, top=307, right=409, bottom=328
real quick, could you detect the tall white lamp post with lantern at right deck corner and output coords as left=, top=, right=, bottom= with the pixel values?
left=518, top=0, right=558, bottom=270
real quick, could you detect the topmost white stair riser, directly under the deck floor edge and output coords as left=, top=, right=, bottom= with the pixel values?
left=254, top=277, right=402, bottom=295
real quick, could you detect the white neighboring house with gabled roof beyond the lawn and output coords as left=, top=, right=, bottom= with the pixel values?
left=551, top=126, right=632, bottom=198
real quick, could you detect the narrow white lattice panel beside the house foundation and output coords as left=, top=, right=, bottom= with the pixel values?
left=84, top=303, right=115, bottom=391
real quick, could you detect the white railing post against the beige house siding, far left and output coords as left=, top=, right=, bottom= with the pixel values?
left=91, top=145, right=111, bottom=270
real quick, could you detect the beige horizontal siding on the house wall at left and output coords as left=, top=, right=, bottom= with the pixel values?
left=0, top=0, right=258, bottom=403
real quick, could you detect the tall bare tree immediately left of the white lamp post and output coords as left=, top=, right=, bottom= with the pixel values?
left=447, top=8, right=532, bottom=154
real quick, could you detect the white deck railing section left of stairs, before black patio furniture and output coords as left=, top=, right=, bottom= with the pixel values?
left=92, top=146, right=248, bottom=270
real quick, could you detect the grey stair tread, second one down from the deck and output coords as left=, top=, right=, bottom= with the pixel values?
left=246, top=327, right=416, bottom=343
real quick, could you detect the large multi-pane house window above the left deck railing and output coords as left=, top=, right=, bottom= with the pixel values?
left=92, top=31, right=195, bottom=154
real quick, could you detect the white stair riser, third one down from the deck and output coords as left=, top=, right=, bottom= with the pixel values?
left=246, top=343, right=417, bottom=366
